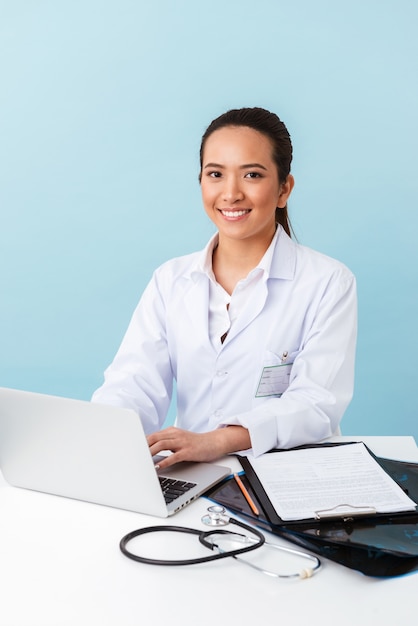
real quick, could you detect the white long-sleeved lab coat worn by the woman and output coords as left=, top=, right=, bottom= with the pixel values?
left=92, top=229, right=357, bottom=455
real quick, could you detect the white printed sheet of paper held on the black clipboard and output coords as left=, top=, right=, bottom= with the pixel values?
left=248, top=443, right=416, bottom=521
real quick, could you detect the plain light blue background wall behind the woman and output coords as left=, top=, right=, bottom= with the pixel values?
left=0, top=0, right=418, bottom=441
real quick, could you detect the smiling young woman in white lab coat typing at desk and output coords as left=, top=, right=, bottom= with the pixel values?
left=93, top=108, right=357, bottom=468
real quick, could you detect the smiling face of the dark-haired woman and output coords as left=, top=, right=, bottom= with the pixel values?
left=201, top=126, right=293, bottom=246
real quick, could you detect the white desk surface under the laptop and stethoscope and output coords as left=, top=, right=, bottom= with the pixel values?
left=0, top=437, right=418, bottom=626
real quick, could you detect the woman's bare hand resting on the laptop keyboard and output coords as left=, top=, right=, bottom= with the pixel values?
left=147, top=426, right=251, bottom=469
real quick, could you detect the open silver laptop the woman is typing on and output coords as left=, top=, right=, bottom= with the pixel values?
left=0, top=388, right=230, bottom=517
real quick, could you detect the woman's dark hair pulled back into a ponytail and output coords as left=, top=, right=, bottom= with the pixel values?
left=200, top=107, right=292, bottom=237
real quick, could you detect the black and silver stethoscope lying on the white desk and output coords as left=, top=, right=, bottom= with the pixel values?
left=119, top=505, right=321, bottom=578
